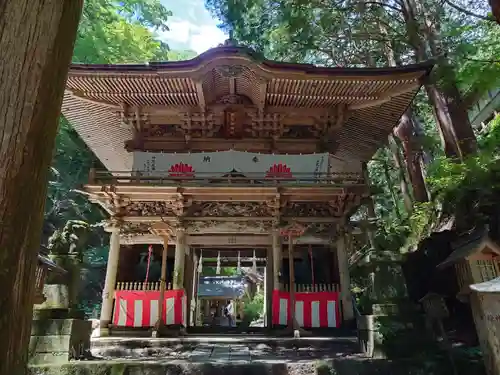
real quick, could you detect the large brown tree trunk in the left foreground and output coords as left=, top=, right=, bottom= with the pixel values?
left=0, top=0, right=83, bottom=375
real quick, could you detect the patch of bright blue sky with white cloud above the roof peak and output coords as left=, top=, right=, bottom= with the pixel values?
left=160, top=0, right=227, bottom=53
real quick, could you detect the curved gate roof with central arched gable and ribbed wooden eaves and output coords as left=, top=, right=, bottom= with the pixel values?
left=62, top=46, right=433, bottom=171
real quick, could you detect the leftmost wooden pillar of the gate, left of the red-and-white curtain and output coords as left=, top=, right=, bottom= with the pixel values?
left=100, top=223, right=120, bottom=336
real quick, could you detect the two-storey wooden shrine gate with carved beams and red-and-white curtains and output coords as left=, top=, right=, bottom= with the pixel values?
left=62, top=44, right=432, bottom=333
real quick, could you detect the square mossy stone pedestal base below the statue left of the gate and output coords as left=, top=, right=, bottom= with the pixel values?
left=29, top=318, right=92, bottom=364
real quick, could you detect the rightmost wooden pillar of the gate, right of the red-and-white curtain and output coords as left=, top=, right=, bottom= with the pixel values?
left=336, top=228, right=354, bottom=321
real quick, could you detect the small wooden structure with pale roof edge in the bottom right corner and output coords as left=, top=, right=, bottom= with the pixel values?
left=470, top=277, right=500, bottom=375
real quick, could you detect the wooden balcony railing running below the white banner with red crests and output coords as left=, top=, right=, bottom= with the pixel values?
left=89, top=169, right=365, bottom=186
